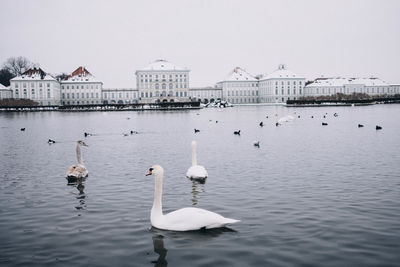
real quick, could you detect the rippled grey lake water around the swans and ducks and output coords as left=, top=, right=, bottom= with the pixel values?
left=0, top=105, right=400, bottom=266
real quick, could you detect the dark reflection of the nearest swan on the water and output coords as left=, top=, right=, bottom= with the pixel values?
left=150, top=227, right=236, bottom=267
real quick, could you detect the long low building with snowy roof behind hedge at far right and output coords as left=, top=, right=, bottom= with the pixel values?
left=304, top=77, right=400, bottom=96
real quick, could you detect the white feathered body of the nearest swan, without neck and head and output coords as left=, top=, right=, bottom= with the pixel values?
left=151, top=207, right=239, bottom=231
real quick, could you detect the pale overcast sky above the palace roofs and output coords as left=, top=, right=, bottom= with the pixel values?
left=0, top=0, right=400, bottom=88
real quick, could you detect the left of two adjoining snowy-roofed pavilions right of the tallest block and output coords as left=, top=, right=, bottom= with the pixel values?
left=217, top=67, right=259, bottom=104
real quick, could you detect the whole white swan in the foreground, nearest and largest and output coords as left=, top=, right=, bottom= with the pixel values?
left=146, top=165, right=239, bottom=231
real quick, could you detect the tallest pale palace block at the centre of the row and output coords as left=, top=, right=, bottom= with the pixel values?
left=135, top=59, right=190, bottom=102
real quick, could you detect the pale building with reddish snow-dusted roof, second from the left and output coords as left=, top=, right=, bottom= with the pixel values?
left=61, top=66, right=103, bottom=106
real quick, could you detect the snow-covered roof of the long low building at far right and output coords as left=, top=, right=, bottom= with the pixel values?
left=307, top=77, right=389, bottom=87
